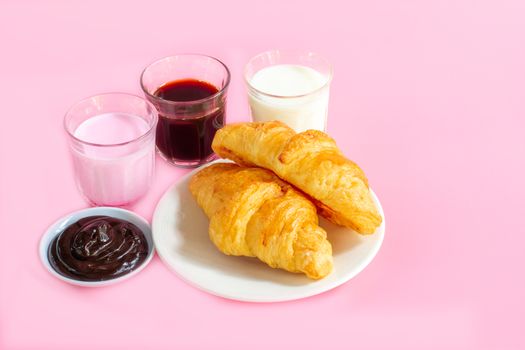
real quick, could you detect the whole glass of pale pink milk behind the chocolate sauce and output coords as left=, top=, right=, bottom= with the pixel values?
left=64, top=93, right=158, bottom=206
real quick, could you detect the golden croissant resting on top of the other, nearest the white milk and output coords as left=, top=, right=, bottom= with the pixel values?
left=212, top=121, right=382, bottom=234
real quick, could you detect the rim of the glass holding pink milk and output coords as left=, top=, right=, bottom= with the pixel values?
left=63, top=92, right=158, bottom=148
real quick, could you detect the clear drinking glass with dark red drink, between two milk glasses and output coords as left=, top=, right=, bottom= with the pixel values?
left=140, top=54, right=230, bottom=167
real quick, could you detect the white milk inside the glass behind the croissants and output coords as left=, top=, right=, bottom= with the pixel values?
left=248, top=64, right=329, bottom=132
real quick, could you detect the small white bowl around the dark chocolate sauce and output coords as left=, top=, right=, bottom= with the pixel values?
left=39, top=207, right=154, bottom=287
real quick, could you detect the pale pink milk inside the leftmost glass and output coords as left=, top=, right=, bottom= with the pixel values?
left=72, top=113, right=155, bottom=206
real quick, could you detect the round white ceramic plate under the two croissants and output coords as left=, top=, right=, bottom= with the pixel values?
left=152, top=160, right=385, bottom=302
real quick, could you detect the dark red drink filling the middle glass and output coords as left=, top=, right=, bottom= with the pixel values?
left=154, top=79, right=225, bottom=163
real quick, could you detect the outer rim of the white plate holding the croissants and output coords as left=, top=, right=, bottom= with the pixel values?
left=151, top=158, right=386, bottom=303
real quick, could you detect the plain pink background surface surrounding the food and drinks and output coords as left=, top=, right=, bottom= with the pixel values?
left=0, top=0, right=525, bottom=350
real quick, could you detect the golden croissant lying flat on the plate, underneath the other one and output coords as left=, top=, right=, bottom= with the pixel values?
left=190, top=163, right=333, bottom=279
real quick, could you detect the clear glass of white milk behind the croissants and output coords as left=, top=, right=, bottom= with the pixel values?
left=244, top=50, right=333, bottom=132
